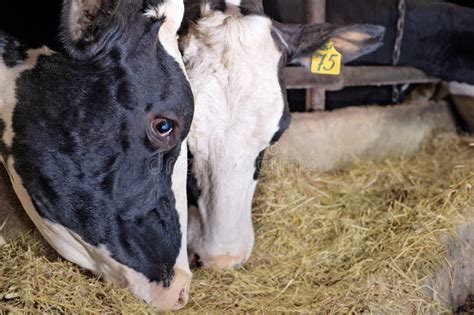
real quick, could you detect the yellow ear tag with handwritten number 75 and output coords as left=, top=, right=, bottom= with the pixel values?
left=311, top=42, right=342, bottom=75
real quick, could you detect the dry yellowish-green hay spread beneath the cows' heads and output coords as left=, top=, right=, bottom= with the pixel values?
left=0, top=135, right=474, bottom=313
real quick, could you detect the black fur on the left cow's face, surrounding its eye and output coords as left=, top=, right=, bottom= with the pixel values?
left=2, top=1, right=193, bottom=285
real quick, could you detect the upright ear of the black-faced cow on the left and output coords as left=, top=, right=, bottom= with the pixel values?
left=61, top=0, right=119, bottom=59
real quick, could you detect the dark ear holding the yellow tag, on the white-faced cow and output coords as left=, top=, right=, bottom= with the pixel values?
left=273, top=22, right=385, bottom=66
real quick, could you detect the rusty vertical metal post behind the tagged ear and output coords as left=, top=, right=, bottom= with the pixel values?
left=306, top=0, right=326, bottom=112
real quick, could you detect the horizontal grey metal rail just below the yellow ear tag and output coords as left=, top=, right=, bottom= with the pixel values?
left=284, top=66, right=441, bottom=91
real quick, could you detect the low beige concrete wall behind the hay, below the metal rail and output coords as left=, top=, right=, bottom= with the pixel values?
left=270, top=102, right=456, bottom=171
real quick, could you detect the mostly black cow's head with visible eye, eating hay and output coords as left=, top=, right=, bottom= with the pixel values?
left=0, top=0, right=193, bottom=309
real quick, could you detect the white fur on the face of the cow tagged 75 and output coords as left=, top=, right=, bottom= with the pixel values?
left=182, top=9, right=284, bottom=267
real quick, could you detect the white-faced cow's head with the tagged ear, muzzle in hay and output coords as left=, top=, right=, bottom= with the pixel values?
left=180, top=0, right=384, bottom=268
